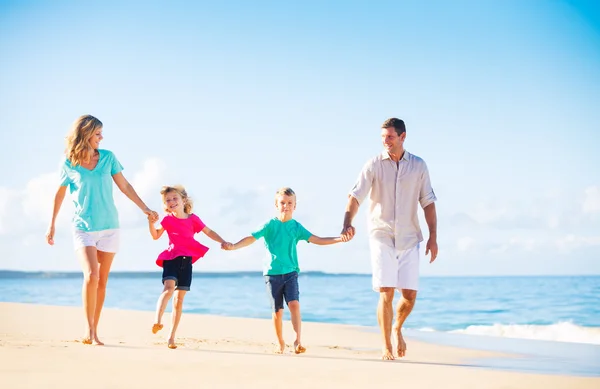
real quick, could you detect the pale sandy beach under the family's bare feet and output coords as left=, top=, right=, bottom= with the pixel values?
left=0, top=303, right=600, bottom=389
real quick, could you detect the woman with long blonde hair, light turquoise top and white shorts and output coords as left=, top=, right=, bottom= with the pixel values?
left=46, top=115, right=158, bottom=345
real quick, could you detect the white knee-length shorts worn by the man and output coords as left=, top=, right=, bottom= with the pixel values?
left=369, top=239, right=419, bottom=292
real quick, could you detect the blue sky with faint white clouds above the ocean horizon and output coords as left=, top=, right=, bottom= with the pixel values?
left=0, top=0, right=600, bottom=275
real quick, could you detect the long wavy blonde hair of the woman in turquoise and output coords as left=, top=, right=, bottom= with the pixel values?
left=65, top=115, right=102, bottom=166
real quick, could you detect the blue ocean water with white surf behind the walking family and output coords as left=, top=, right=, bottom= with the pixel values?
left=0, top=271, right=600, bottom=376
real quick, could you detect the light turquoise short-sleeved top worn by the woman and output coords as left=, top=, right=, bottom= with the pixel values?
left=60, top=149, right=123, bottom=232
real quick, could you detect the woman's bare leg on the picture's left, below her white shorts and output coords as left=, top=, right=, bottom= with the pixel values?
left=77, top=246, right=100, bottom=344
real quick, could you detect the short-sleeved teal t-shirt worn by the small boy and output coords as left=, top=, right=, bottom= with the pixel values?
left=252, top=218, right=312, bottom=276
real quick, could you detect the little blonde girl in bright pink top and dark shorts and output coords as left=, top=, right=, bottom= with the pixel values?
left=148, top=185, right=229, bottom=349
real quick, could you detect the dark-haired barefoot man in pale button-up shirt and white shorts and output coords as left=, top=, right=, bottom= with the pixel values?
left=342, top=118, right=438, bottom=360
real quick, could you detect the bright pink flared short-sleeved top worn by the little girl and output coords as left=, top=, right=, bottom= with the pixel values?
left=156, top=213, right=208, bottom=267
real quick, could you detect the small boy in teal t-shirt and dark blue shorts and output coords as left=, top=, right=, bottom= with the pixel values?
left=223, top=188, right=350, bottom=354
